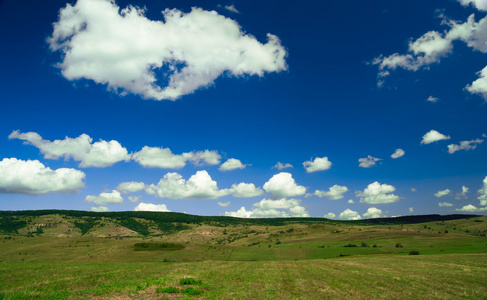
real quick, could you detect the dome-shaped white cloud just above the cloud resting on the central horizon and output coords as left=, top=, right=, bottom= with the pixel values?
left=263, top=172, right=306, bottom=199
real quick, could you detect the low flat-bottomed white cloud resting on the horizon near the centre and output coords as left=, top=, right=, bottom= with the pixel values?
left=225, top=199, right=309, bottom=218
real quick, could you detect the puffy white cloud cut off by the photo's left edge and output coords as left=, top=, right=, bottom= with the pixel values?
left=0, top=158, right=86, bottom=195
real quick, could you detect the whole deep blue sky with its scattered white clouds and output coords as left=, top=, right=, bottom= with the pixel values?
left=0, top=0, right=487, bottom=219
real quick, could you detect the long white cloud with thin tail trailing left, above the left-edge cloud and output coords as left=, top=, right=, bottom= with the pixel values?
left=8, top=130, right=130, bottom=167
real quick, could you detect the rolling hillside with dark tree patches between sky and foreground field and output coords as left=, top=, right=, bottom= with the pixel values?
left=0, top=210, right=487, bottom=262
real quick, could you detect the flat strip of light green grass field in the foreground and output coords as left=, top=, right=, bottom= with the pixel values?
left=0, top=254, right=487, bottom=299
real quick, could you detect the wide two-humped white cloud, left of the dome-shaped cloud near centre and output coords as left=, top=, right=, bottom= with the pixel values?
left=146, top=171, right=233, bottom=199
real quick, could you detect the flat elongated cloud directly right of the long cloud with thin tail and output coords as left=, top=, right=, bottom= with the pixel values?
left=132, top=146, right=221, bottom=169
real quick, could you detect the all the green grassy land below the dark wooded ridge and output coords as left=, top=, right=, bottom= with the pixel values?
left=0, top=215, right=487, bottom=299
